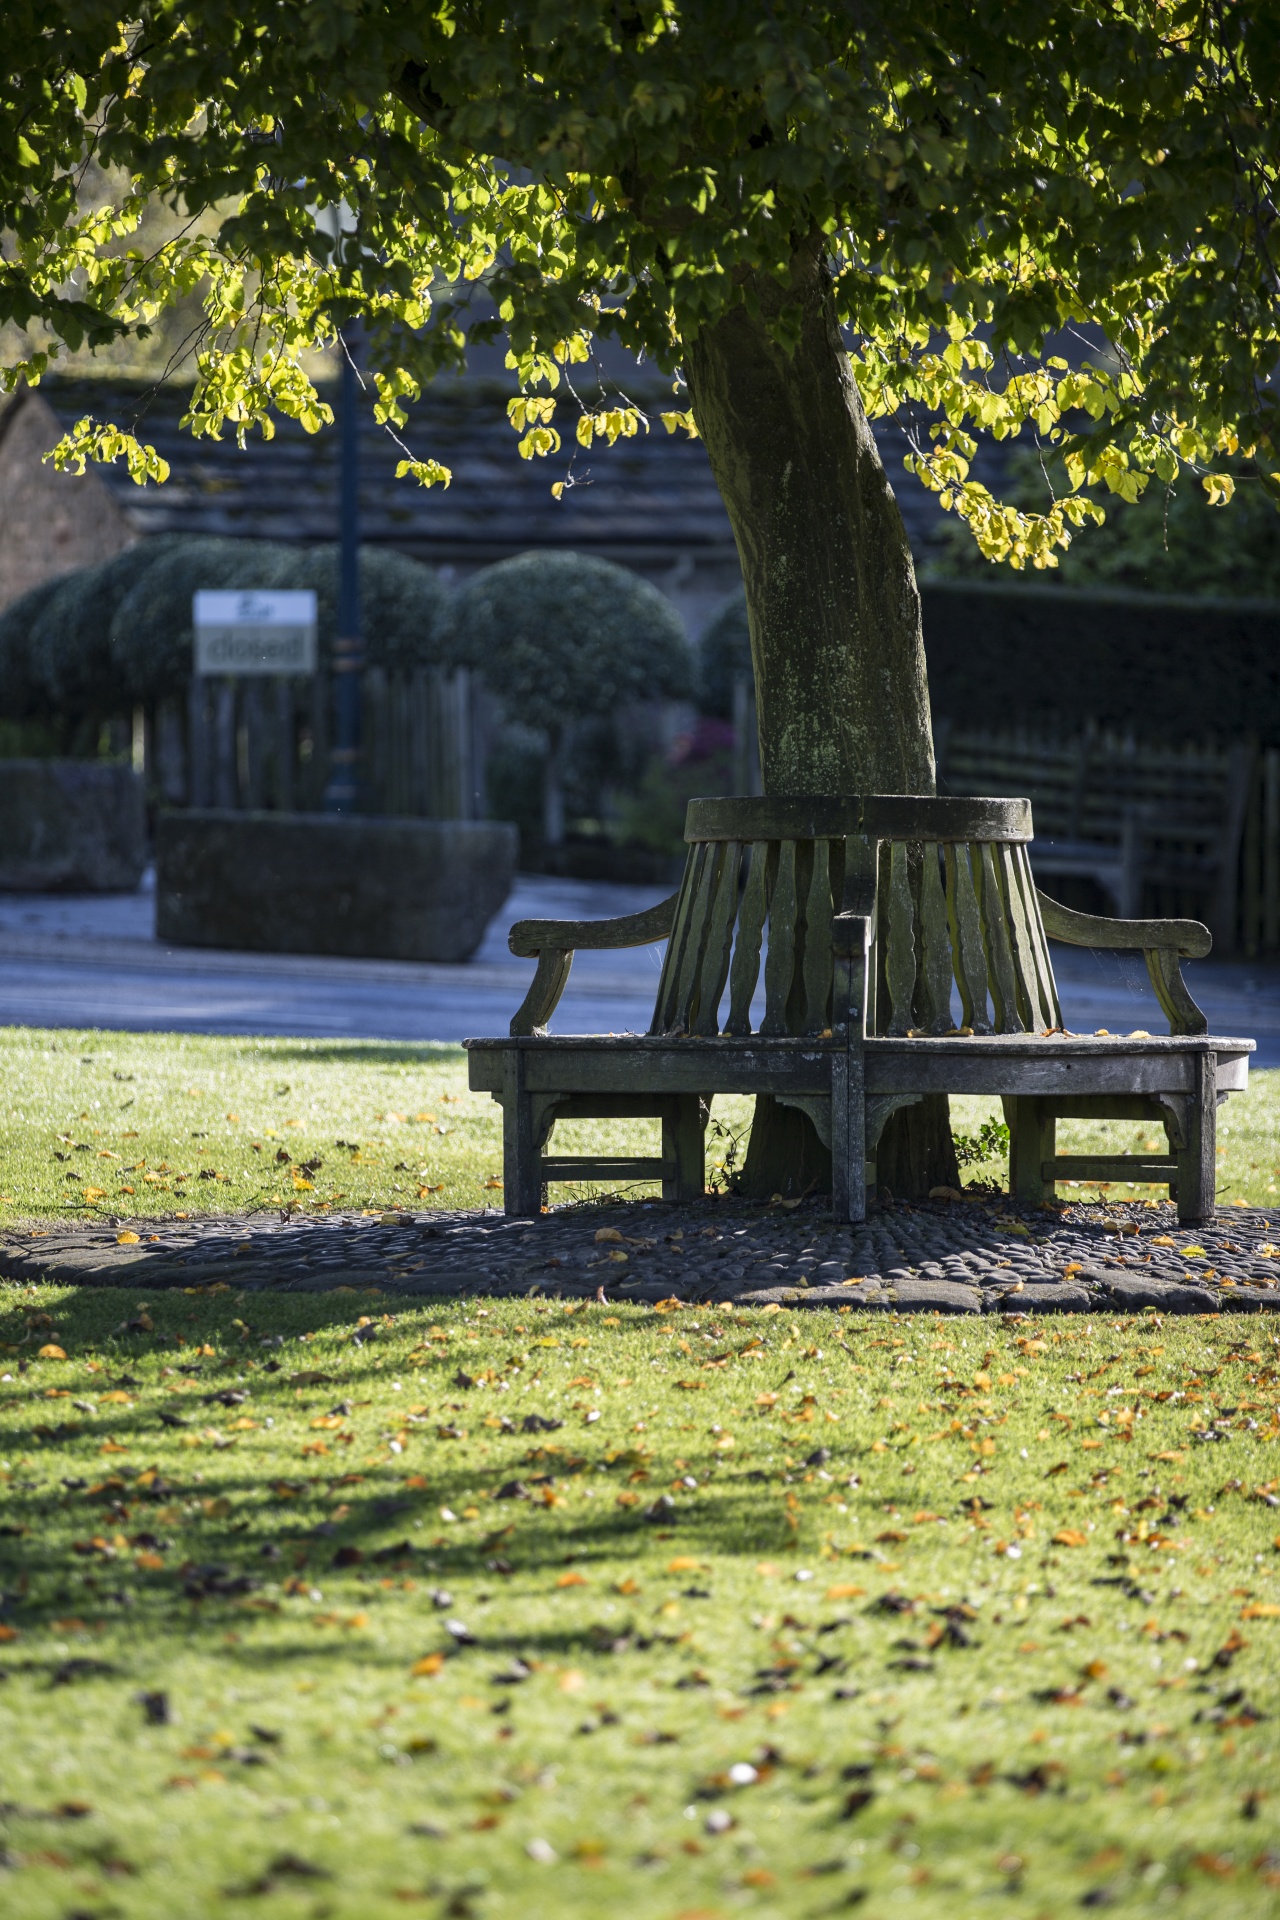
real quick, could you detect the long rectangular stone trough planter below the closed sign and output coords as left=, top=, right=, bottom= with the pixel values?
left=155, top=808, right=516, bottom=962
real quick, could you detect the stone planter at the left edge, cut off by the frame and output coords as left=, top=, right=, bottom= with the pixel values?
left=0, top=760, right=146, bottom=893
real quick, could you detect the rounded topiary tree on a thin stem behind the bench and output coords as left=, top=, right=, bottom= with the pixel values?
left=453, top=553, right=693, bottom=847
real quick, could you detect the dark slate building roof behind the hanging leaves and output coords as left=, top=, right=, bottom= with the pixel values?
left=40, top=376, right=959, bottom=566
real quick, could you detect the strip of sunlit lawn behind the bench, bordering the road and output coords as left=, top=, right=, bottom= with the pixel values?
left=0, top=1027, right=1280, bottom=1221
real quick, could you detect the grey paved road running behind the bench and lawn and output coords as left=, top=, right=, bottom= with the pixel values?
left=0, top=876, right=1280, bottom=1066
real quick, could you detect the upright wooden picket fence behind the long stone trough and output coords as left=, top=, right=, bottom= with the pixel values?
left=132, top=666, right=489, bottom=820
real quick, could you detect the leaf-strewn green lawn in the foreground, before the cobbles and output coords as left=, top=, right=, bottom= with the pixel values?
left=0, top=1288, right=1280, bottom=1920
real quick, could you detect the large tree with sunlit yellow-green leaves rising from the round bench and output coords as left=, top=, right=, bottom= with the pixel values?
left=0, top=0, right=1280, bottom=1179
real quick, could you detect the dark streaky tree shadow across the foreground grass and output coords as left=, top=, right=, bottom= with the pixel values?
left=0, top=1288, right=856, bottom=1644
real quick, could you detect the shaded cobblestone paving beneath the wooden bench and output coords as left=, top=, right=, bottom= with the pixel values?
left=0, top=1194, right=1280, bottom=1313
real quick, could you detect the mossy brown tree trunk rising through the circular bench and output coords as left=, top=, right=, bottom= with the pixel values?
left=685, top=236, right=958, bottom=1196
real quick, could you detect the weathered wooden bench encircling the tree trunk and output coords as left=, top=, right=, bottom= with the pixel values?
left=466, top=795, right=1253, bottom=1221
